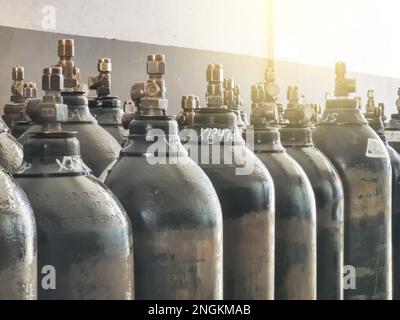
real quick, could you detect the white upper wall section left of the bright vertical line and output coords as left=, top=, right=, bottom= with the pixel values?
left=0, top=0, right=268, bottom=57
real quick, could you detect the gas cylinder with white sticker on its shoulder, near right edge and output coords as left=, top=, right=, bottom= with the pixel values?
left=313, top=62, right=392, bottom=300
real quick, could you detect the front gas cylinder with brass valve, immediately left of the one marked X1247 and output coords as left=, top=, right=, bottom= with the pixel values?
left=105, top=54, right=222, bottom=300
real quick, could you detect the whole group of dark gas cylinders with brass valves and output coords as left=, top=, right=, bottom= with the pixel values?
left=0, top=39, right=400, bottom=300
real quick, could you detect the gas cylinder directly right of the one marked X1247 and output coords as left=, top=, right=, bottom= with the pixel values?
left=247, top=82, right=317, bottom=300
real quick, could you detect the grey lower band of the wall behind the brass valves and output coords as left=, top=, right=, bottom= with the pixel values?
left=0, top=27, right=400, bottom=115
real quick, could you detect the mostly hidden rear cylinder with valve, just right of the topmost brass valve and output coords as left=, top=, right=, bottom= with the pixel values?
left=89, top=58, right=125, bottom=144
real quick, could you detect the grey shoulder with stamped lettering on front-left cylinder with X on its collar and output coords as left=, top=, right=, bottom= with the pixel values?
left=17, top=176, right=129, bottom=229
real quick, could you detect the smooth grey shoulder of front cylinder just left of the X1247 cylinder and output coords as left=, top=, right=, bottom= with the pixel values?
left=105, top=156, right=222, bottom=229
